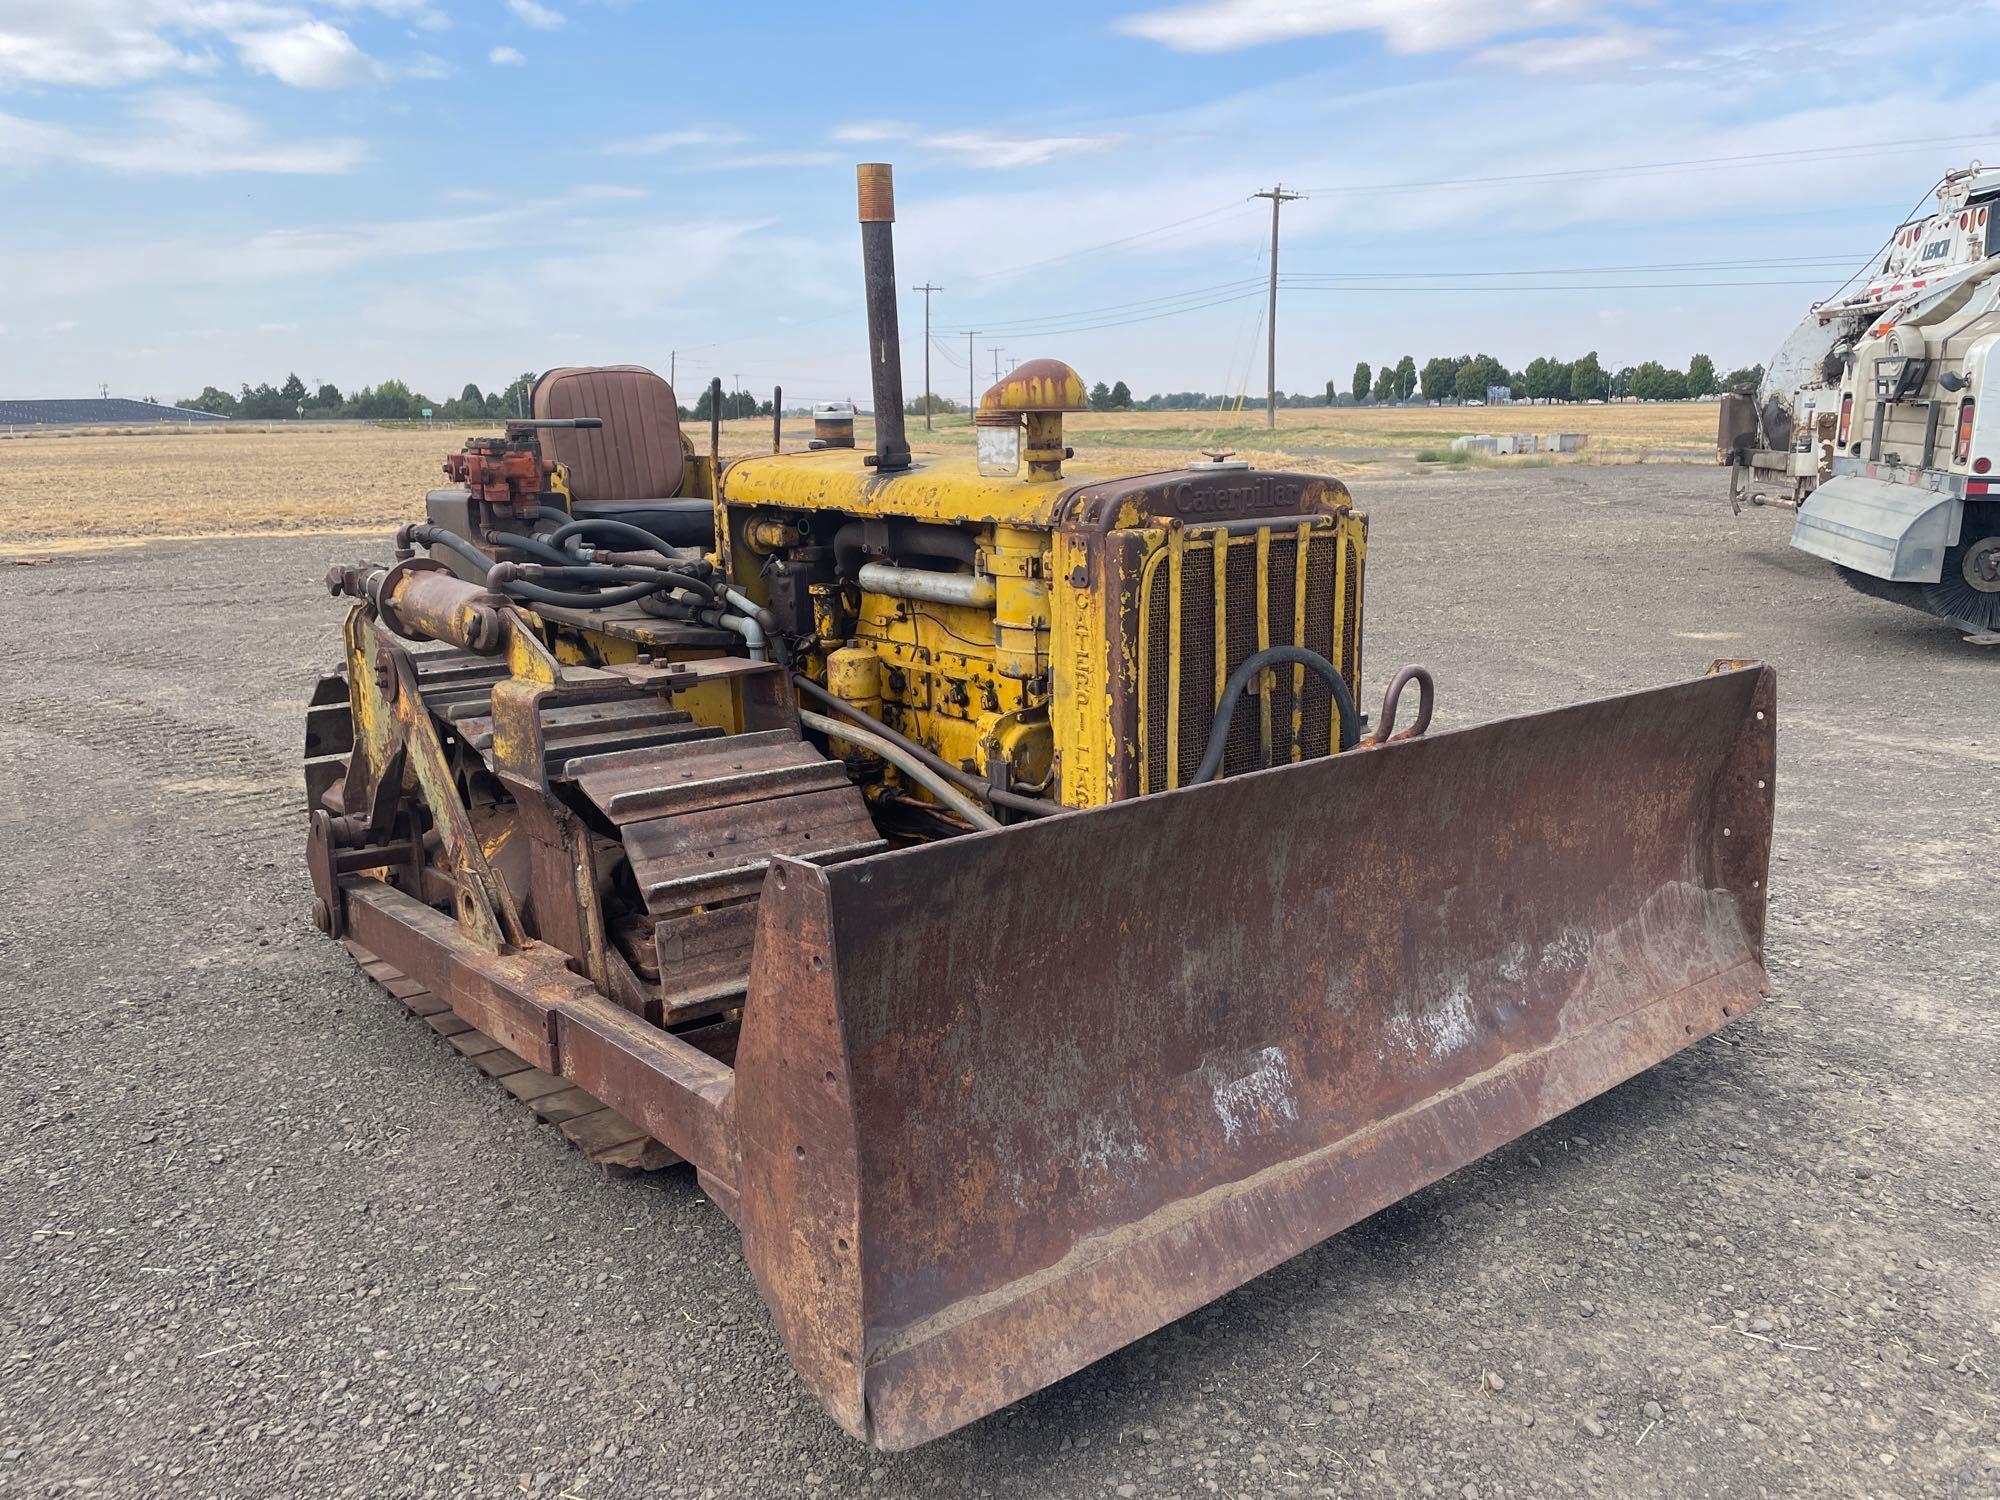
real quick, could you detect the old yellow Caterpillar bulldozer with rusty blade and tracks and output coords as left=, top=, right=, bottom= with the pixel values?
left=306, top=166, right=1776, bottom=1448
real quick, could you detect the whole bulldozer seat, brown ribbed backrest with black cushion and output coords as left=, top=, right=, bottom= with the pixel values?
left=534, top=364, right=714, bottom=546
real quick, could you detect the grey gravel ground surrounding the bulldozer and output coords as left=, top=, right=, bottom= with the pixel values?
left=0, top=466, right=2000, bottom=1500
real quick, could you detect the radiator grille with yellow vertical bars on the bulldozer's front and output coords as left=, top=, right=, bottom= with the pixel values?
left=1138, top=526, right=1360, bottom=792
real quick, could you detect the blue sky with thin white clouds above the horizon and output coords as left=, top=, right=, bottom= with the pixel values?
left=0, top=0, right=2000, bottom=400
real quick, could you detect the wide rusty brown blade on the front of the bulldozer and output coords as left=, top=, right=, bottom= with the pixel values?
left=734, top=664, right=1776, bottom=1448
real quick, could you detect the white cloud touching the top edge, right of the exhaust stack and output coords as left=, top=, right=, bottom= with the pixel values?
left=1118, top=0, right=1590, bottom=52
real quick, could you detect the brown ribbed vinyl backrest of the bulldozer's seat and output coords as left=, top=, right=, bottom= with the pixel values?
left=534, top=364, right=686, bottom=504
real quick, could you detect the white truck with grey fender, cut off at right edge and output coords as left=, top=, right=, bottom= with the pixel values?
left=1716, top=164, right=2000, bottom=638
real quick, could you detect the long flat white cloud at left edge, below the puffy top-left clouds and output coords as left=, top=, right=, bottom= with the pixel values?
left=0, top=94, right=364, bottom=176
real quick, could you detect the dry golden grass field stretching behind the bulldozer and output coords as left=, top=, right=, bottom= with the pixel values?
left=0, top=402, right=1714, bottom=554
